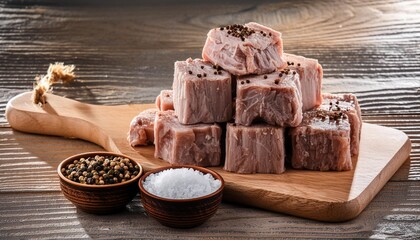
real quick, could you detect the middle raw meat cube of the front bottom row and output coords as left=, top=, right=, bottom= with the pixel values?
left=224, top=123, right=285, bottom=174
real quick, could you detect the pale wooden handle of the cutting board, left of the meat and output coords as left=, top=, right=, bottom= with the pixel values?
left=6, top=92, right=121, bottom=153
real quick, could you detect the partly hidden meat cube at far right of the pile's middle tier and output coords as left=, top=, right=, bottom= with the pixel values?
left=283, top=53, right=323, bottom=111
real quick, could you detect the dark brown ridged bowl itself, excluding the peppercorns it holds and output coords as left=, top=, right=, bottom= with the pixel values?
left=57, top=152, right=143, bottom=214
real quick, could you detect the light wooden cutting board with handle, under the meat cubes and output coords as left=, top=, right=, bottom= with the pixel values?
left=6, top=92, right=411, bottom=222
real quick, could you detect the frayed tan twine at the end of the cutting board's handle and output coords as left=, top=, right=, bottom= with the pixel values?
left=32, top=62, right=76, bottom=105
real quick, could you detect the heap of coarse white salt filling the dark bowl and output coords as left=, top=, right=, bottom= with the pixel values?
left=143, top=168, right=222, bottom=199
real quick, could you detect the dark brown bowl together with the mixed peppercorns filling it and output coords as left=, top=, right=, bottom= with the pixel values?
left=57, top=152, right=143, bottom=214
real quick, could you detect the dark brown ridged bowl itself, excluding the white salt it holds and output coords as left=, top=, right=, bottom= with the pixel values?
left=139, top=165, right=225, bottom=228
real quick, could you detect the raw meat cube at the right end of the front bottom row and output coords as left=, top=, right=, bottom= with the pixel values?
left=289, top=108, right=352, bottom=171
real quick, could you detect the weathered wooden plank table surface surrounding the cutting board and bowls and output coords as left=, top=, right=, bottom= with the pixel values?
left=0, top=0, right=420, bottom=239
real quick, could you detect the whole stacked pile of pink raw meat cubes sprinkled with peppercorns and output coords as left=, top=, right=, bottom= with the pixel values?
left=128, top=23, right=362, bottom=174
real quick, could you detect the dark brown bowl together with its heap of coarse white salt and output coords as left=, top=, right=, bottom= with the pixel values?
left=139, top=165, right=225, bottom=228
